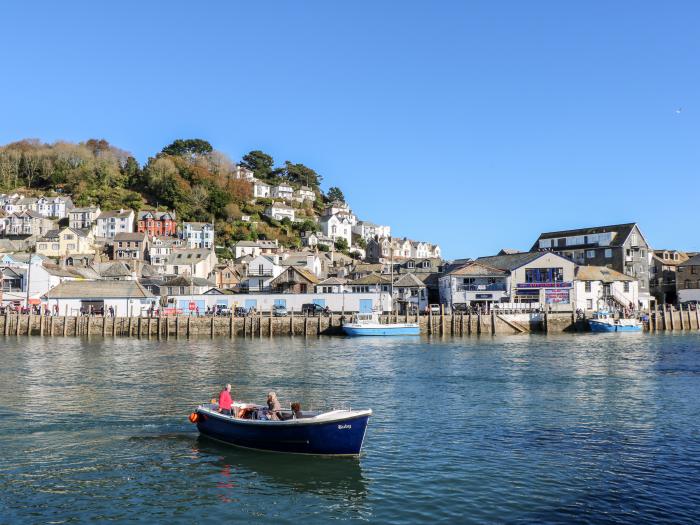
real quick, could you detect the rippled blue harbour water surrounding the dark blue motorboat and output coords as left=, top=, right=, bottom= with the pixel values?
left=0, top=334, right=700, bottom=524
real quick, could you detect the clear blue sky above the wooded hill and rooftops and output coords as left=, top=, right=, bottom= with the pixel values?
left=0, top=0, right=700, bottom=258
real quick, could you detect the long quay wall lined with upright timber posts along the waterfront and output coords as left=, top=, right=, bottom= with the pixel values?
left=0, top=309, right=700, bottom=339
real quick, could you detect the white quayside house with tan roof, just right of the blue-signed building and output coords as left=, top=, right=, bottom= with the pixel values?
left=573, top=266, right=639, bottom=311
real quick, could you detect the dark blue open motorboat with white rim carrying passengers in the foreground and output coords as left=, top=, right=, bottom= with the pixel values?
left=190, top=403, right=372, bottom=456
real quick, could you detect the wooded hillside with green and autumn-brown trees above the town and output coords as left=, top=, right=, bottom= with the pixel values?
left=0, top=139, right=342, bottom=252
